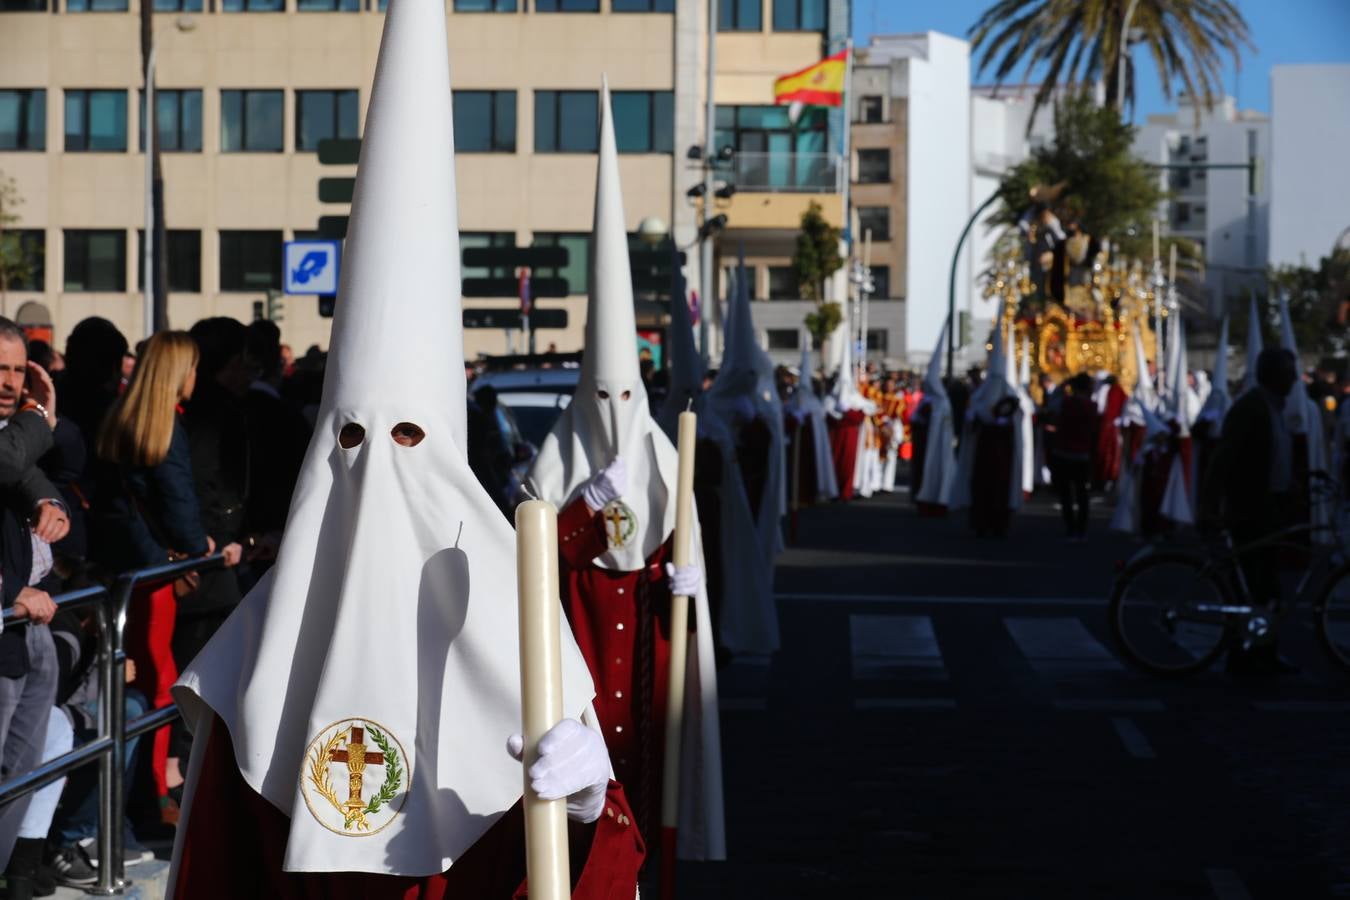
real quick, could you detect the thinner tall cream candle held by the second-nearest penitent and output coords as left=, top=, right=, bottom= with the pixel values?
left=662, top=410, right=710, bottom=900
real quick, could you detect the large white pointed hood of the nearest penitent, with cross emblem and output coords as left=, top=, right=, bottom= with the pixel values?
left=166, top=0, right=593, bottom=876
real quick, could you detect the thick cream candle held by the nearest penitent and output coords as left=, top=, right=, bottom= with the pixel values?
left=516, top=501, right=571, bottom=900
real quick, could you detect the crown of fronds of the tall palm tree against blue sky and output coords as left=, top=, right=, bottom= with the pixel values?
left=969, top=0, right=1253, bottom=121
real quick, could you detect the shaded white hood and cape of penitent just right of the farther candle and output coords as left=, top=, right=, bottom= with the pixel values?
left=707, top=253, right=787, bottom=565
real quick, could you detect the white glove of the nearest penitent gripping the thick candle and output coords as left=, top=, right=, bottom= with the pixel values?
left=506, top=719, right=609, bottom=822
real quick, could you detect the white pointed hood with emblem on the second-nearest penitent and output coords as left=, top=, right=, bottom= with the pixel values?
left=527, top=84, right=679, bottom=572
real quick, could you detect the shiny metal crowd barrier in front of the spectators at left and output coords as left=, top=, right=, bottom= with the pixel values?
left=0, top=553, right=225, bottom=896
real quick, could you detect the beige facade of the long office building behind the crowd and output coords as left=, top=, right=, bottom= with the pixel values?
left=0, top=0, right=842, bottom=367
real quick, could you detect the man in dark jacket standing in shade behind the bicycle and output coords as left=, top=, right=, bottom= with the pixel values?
left=1200, top=348, right=1299, bottom=672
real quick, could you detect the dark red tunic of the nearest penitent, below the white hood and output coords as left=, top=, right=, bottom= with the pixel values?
left=174, top=719, right=645, bottom=900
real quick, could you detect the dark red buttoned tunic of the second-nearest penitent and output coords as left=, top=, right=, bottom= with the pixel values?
left=558, top=498, right=671, bottom=839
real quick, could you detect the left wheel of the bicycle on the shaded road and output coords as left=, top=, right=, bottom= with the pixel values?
left=1110, top=553, right=1229, bottom=677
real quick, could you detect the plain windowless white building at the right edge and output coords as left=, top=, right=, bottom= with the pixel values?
left=1262, top=65, right=1350, bottom=267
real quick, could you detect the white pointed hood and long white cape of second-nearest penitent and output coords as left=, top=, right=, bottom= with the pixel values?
left=525, top=84, right=736, bottom=860
